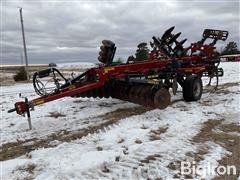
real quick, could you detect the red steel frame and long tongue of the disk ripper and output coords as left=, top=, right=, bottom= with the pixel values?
left=9, top=37, right=220, bottom=114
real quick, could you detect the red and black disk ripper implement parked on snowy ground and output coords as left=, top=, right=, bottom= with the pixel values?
left=8, top=27, right=228, bottom=129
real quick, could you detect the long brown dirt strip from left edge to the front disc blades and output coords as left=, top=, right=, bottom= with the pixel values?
left=0, top=106, right=151, bottom=161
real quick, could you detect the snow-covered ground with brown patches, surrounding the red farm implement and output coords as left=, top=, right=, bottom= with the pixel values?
left=0, top=63, right=240, bottom=179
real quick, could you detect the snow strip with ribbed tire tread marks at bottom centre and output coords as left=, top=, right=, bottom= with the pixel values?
left=82, top=120, right=195, bottom=179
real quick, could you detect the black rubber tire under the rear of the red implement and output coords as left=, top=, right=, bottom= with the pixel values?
left=183, top=75, right=203, bottom=102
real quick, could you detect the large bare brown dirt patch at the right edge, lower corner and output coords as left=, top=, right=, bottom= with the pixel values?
left=190, top=119, right=240, bottom=179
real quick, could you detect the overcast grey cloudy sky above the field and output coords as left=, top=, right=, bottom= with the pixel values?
left=1, top=0, right=240, bottom=64
